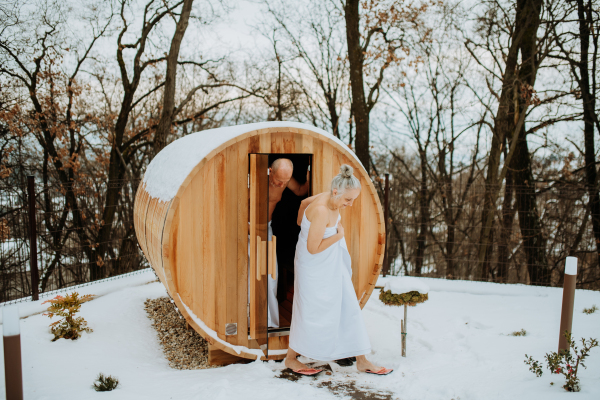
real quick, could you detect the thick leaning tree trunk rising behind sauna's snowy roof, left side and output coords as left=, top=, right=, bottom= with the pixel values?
left=152, top=0, right=194, bottom=156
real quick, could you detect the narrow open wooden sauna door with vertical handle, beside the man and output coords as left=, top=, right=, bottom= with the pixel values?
left=249, top=154, right=273, bottom=357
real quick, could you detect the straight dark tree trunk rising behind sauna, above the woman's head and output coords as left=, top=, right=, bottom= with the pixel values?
left=344, top=0, right=371, bottom=174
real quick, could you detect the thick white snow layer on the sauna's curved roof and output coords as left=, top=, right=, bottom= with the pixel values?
left=143, top=121, right=362, bottom=201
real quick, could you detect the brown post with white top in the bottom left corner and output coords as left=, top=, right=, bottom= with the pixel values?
left=2, top=306, right=23, bottom=400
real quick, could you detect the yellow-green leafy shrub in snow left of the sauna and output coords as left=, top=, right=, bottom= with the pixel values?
left=42, top=292, right=94, bottom=342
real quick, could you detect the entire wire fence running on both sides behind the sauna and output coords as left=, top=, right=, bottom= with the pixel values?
left=0, top=174, right=600, bottom=302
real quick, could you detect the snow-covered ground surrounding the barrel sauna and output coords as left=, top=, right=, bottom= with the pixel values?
left=0, top=271, right=600, bottom=400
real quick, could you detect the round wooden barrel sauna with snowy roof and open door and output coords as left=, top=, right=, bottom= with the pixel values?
left=134, top=122, right=385, bottom=364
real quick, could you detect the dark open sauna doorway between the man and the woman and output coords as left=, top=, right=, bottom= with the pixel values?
left=269, top=154, right=312, bottom=328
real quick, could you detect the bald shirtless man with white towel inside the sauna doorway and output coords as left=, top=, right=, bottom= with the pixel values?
left=267, top=158, right=309, bottom=328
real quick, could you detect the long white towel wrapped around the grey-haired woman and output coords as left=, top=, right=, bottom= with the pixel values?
left=289, top=211, right=371, bottom=361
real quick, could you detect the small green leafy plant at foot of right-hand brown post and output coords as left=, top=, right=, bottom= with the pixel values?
left=525, top=331, right=598, bottom=392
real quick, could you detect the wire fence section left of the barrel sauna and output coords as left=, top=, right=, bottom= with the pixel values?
left=0, top=180, right=148, bottom=302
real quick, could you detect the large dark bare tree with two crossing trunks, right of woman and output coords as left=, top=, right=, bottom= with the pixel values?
left=466, top=0, right=555, bottom=283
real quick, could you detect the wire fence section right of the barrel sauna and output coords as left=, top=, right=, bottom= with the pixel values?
left=381, top=179, right=600, bottom=290
